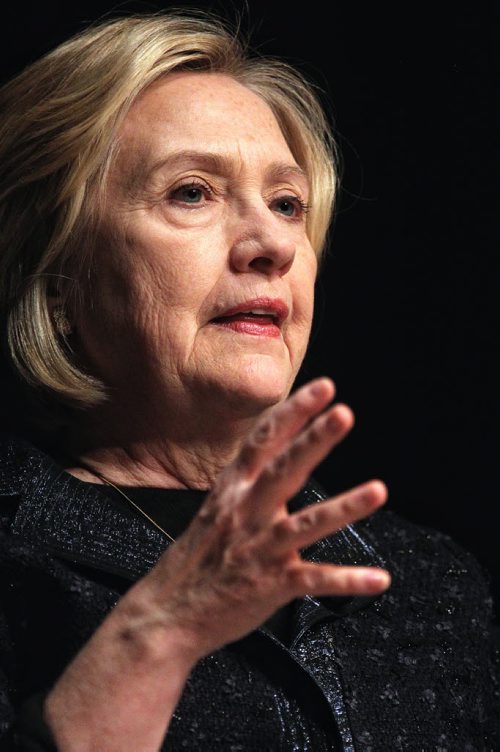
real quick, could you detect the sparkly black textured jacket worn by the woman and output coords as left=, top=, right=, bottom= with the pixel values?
left=0, top=439, right=500, bottom=752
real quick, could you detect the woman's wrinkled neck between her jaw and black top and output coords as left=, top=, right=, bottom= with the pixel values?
left=64, top=394, right=272, bottom=490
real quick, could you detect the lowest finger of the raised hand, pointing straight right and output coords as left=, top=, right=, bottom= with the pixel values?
left=287, top=561, right=391, bottom=598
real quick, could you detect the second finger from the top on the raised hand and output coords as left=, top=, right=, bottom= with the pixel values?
left=249, top=405, right=354, bottom=514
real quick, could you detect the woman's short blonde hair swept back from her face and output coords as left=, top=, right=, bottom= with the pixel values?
left=0, top=11, right=336, bottom=407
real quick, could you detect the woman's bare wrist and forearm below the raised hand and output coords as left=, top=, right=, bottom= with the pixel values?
left=44, top=588, right=197, bottom=752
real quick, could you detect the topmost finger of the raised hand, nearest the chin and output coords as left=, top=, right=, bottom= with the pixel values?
left=231, top=378, right=335, bottom=478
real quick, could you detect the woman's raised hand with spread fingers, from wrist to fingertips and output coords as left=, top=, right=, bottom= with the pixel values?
left=137, top=379, right=390, bottom=657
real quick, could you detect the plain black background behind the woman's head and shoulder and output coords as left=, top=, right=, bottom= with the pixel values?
left=0, top=0, right=500, bottom=610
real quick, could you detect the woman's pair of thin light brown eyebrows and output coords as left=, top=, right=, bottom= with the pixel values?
left=138, top=149, right=309, bottom=184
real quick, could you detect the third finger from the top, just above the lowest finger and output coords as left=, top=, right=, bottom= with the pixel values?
left=268, top=480, right=387, bottom=557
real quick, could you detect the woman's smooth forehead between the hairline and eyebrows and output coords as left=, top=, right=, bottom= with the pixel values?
left=114, top=72, right=297, bottom=181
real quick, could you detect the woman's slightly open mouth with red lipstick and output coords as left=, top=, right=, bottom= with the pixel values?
left=210, top=298, right=288, bottom=337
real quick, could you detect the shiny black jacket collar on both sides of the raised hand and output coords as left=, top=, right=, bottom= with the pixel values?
left=0, top=437, right=383, bottom=616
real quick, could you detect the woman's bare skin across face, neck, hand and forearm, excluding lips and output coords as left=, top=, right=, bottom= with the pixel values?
left=46, top=72, right=389, bottom=752
